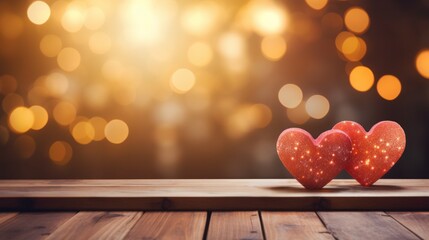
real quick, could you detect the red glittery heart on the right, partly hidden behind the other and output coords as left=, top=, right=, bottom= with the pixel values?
left=333, top=121, right=405, bottom=186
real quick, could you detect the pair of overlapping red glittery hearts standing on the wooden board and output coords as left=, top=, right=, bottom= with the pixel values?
left=277, top=121, right=405, bottom=189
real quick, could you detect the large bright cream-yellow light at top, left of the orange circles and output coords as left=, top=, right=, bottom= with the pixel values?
left=251, top=1, right=288, bottom=36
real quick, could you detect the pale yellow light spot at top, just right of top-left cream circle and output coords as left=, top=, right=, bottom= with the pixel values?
left=61, top=1, right=85, bottom=33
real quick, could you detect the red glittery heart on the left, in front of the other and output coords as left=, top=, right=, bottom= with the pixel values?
left=277, top=128, right=352, bottom=189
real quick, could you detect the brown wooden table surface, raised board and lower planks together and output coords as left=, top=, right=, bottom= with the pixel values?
left=0, top=179, right=429, bottom=239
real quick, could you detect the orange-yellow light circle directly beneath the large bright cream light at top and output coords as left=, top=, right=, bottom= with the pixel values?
left=261, top=35, right=287, bottom=61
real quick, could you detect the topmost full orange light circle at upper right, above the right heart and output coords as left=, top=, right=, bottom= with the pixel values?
left=344, top=7, right=369, bottom=33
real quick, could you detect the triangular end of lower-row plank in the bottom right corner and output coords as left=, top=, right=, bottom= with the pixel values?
left=388, top=212, right=429, bottom=239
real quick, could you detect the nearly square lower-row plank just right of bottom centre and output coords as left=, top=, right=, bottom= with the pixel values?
left=207, top=211, right=263, bottom=240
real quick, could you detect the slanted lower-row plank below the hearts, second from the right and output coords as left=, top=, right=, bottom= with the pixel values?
left=318, top=212, right=419, bottom=240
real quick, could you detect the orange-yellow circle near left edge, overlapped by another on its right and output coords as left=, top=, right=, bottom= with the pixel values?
left=9, top=107, right=34, bottom=133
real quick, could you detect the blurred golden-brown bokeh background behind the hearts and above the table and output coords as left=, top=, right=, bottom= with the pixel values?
left=0, top=0, right=429, bottom=178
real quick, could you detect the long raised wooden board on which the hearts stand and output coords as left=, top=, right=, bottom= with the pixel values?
left=0, top=179, right=429, bottom=211
